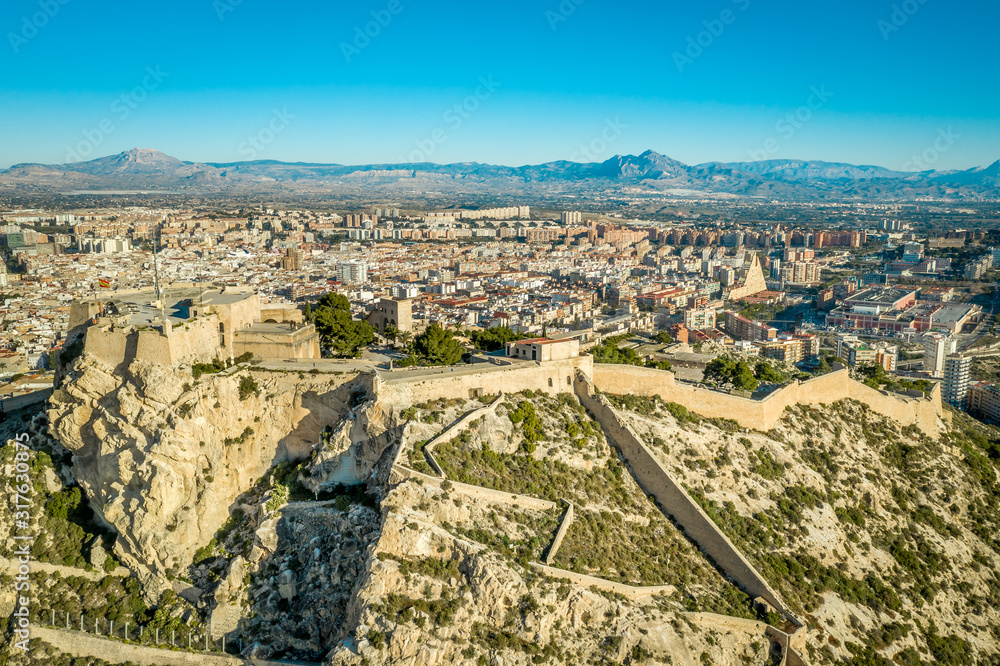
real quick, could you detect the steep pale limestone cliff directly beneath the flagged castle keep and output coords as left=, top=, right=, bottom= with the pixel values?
left=48, top=355, right=371, bottom=588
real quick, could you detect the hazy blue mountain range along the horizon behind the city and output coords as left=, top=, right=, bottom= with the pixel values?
left=0, top=148, right=1000, bottom=201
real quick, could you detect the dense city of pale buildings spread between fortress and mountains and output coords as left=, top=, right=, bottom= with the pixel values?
left=0, top=197, right=1000, bottom=422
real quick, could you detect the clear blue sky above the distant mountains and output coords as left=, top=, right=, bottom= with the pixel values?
left=0, top=0, right=1000, bottom=170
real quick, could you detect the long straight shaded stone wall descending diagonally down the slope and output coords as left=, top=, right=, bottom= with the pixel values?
left=577, top=376, right=791, bottom=616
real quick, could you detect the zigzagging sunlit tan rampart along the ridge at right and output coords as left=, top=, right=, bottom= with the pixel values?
left=591, top=363, right=943, bottom=437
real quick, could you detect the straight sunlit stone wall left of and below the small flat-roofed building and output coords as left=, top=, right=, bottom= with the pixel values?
left=379, top=356, right=593, bottom=405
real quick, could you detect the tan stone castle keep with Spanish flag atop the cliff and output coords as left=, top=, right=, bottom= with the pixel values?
left=69, top=285, right=320, bottom=368
